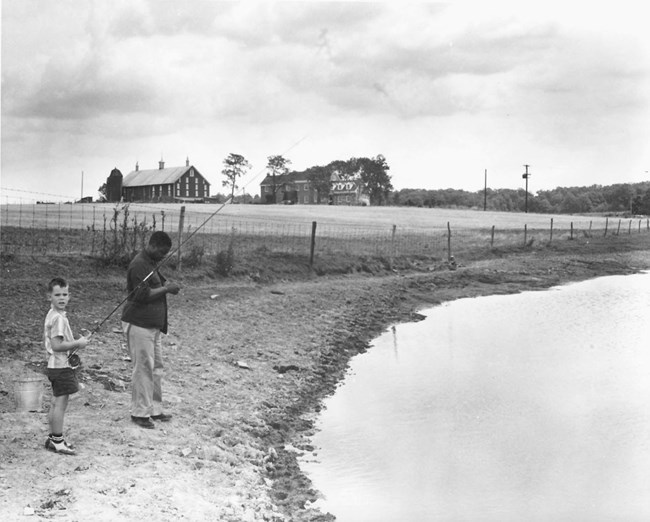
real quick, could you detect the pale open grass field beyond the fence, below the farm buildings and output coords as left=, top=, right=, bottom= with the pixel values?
left=0, top=203, right=618, bottom=230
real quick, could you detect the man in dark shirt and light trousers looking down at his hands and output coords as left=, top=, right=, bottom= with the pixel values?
left=122, top=231, right=180, bottom=428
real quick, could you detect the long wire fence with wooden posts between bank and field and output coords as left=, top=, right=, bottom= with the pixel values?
left=0, top=204, right=650, bottom=261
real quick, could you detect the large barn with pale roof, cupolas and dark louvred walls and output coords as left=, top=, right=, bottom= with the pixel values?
left=122, top=158, right=210, bottom=202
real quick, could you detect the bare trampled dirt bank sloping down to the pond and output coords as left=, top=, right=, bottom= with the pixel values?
left=0, top=238, right=650, bottom=521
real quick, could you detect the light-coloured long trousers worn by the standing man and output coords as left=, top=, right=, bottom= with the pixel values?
left=122, top=322, right=163, bottom=417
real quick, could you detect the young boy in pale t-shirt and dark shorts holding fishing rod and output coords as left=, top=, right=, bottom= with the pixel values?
left=43, top=277, right=88, bottom=455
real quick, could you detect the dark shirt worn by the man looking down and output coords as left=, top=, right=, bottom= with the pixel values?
left=122, top=251, right=167, bottom=333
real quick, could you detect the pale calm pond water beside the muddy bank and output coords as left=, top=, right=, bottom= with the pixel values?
left=301, top=273, right=650, bottom=522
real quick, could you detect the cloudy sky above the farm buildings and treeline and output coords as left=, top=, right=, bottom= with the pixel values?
left=1, top=0, right=650, bottom=203
